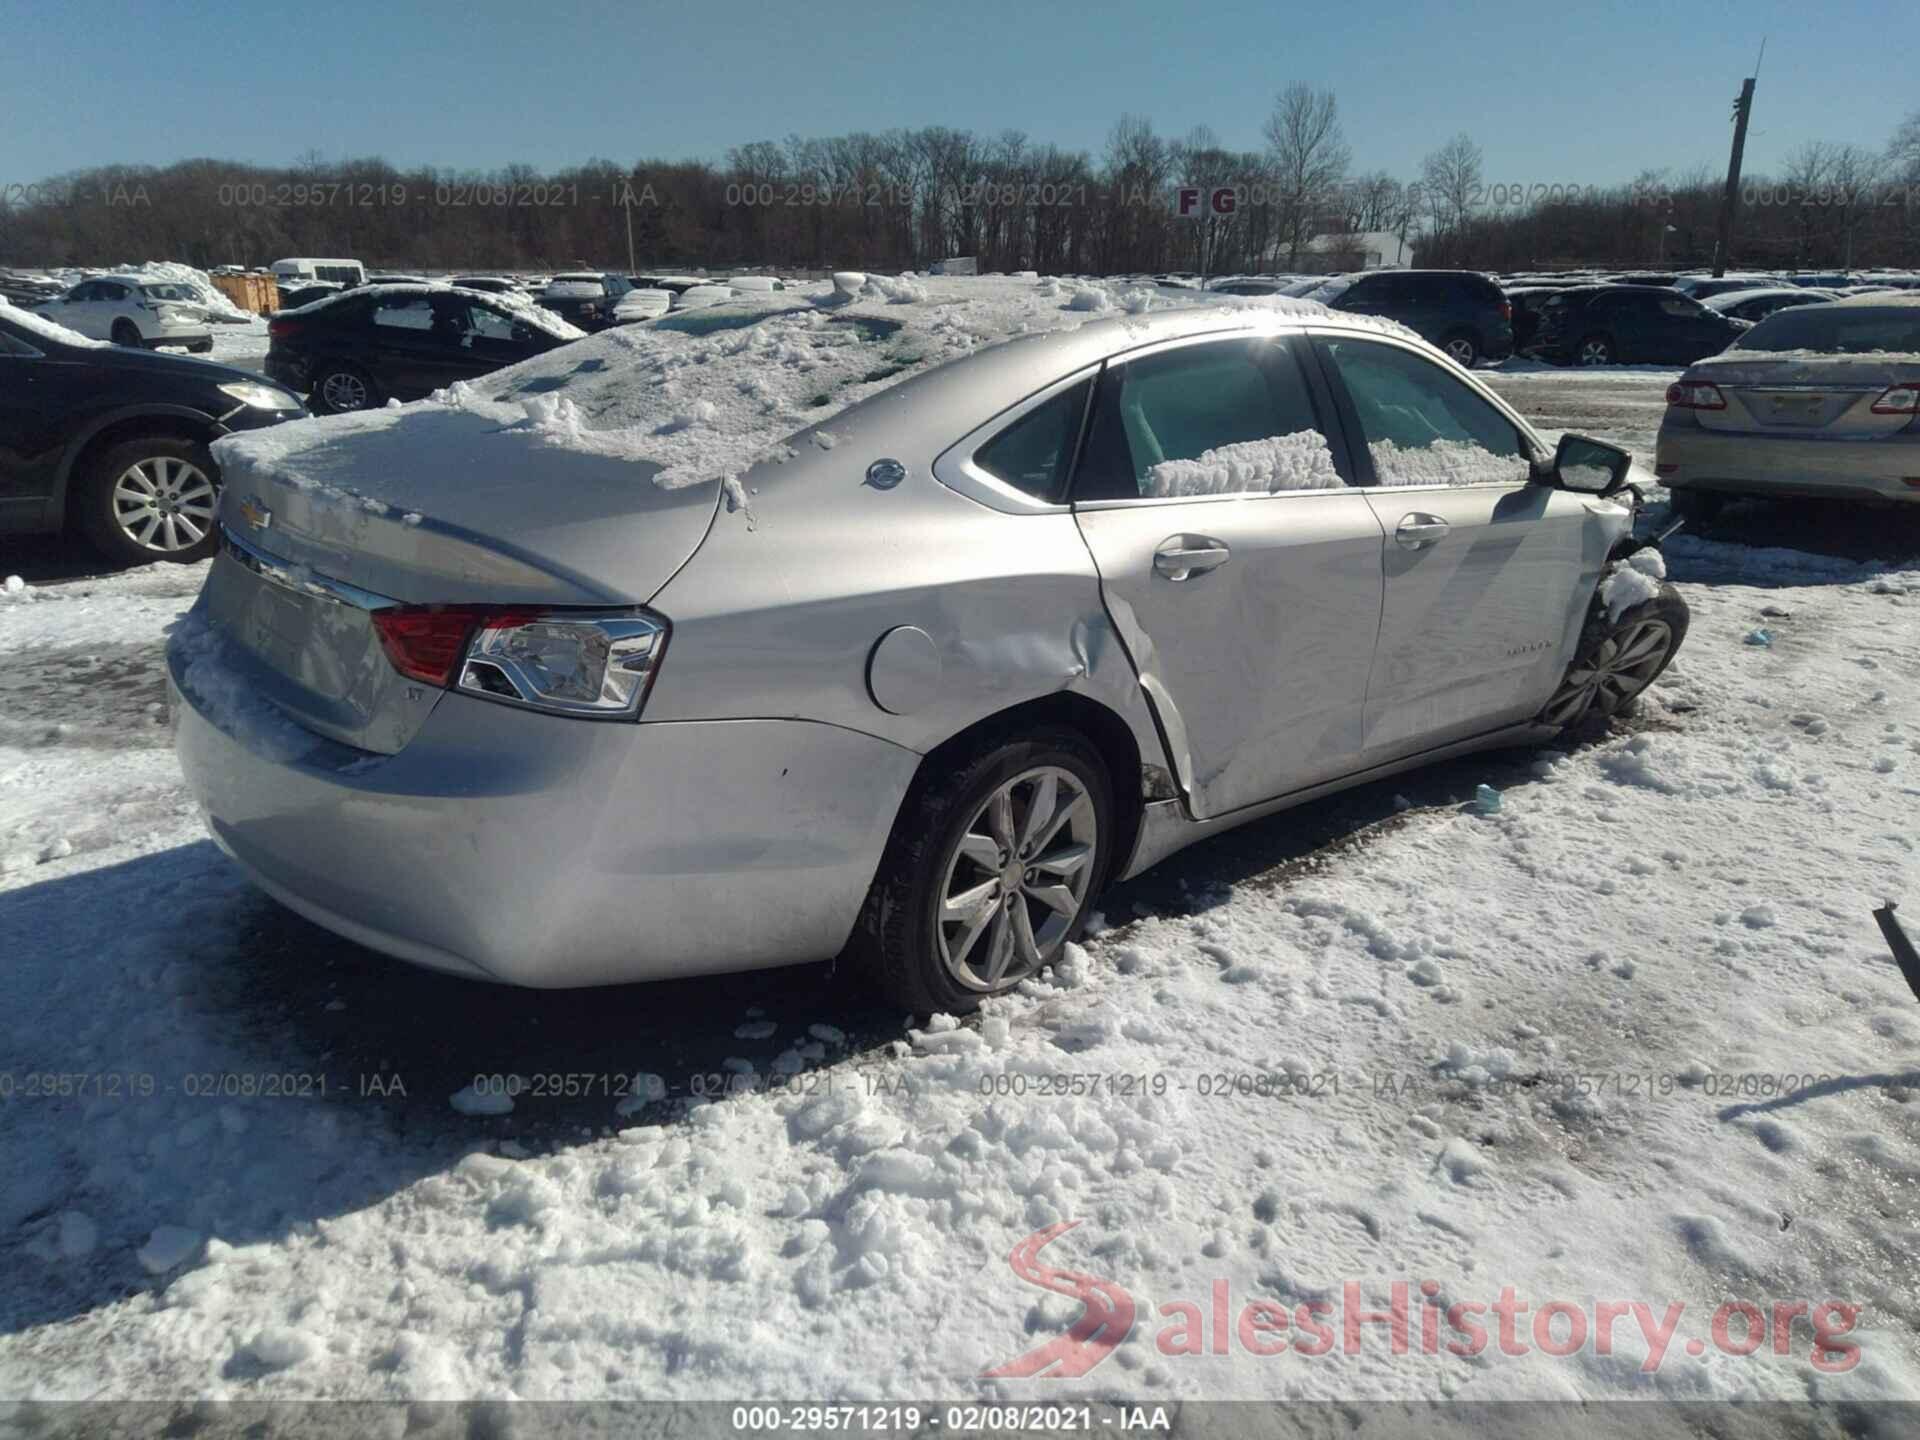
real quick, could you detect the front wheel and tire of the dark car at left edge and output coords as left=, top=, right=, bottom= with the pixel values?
left=75, top=436, right=219, bottom=564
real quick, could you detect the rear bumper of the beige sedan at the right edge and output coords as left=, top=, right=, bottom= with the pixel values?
left=1655, top=424, right=1920, bottom=505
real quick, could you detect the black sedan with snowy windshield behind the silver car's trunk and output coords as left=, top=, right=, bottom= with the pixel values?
left=265, top=286, right=578, bottom=415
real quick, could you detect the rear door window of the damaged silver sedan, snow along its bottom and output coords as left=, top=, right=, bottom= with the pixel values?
left=1073, top=340, right=1346, bottom=501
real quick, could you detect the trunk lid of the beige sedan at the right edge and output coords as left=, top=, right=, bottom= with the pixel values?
left=1688, top=351, right=1920, bottom=440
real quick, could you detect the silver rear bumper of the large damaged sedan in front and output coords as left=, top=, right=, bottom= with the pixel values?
left=167, top=641, right=920, bottom=987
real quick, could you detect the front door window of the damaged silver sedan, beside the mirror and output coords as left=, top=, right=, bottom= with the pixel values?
left=1319, top=338, right=1532, bottom=486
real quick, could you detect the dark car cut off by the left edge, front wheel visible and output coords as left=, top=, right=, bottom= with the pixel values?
left=0, top=305, right=305, bottom=564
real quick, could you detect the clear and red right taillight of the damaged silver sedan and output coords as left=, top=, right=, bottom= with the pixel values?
left=457, top=611, right=668, bottom=718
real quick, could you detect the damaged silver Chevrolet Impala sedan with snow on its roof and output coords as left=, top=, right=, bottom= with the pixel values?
left=169, top=275, right=1686, bottom=1014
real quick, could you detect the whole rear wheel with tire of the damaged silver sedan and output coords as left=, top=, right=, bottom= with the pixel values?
left=849, top=728, right=1114, bottom=1016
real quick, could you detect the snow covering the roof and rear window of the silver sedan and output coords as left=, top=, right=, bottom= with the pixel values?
left=221, top=273, right=1415, bottom=503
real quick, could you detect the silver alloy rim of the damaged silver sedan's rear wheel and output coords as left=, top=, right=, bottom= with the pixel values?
left=935, top=766, right=1100, bottom=991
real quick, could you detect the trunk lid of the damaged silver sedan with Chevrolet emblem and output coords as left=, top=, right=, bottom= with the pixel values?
left=204, top=409, right=720, bottom=755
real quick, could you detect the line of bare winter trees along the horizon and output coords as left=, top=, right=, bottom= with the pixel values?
left=11, top=97, right=1920, bottom=275
